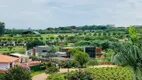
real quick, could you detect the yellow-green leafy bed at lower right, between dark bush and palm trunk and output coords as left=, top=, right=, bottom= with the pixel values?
left=85, top=67, right=133, bottom=80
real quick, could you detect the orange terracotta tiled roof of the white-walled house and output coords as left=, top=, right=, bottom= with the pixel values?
left=0, top=54, right=18, bottom=63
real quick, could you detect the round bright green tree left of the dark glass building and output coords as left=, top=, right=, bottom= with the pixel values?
left=74, top=51, right=90, bottom=68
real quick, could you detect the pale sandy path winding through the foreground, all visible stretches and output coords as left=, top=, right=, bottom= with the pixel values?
left=32, top=65, right=116, bottom=80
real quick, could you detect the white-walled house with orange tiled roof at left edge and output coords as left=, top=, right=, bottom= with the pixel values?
left=0, top=54, right=18, bottom=70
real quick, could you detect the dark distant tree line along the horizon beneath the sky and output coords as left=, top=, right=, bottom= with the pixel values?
left=5, top=25, right=127, bottom=34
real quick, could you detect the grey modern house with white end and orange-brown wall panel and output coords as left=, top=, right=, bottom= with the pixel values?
left=26, top=45, right=53, bottom=56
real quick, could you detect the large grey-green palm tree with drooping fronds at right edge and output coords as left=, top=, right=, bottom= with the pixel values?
left=113, top=43, right=142, bottom=80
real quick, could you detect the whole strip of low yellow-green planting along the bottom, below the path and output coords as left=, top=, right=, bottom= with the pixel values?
left=47, top=67, right=133, bottom=80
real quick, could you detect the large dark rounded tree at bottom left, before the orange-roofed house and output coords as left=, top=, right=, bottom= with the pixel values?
left=3, top=66, right=32, bottom=80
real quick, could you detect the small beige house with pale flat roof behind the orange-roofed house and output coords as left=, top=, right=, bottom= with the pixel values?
left=10, top=53, right=29, bottom=63
